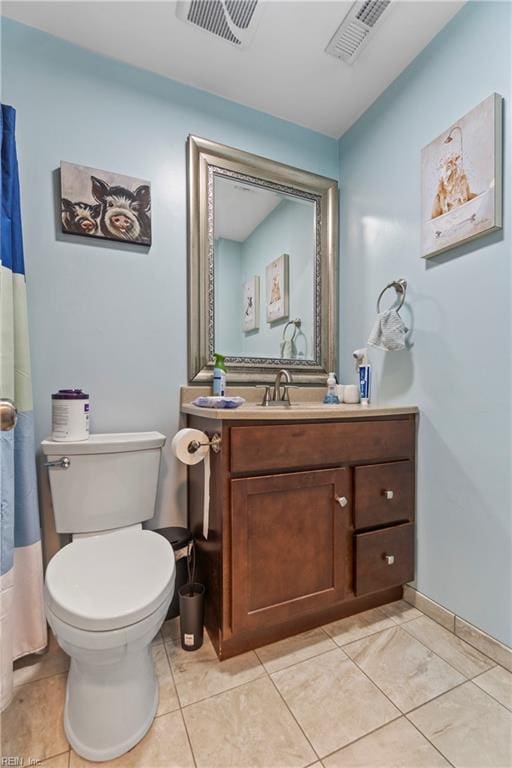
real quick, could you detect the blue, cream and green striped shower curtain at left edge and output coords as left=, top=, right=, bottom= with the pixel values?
left=0, top=105, right=46, bottom=711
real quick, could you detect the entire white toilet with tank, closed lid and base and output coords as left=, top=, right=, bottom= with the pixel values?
left=42, top=432, right=175, bottom=761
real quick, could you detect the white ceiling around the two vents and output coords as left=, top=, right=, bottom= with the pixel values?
left=1, top=0, right=464, bottom=138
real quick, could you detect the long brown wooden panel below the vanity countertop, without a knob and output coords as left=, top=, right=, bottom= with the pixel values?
left=230, top=417, right=415, bottom=473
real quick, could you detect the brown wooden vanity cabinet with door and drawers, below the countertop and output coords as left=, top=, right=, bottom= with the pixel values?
left=189, top=414, right=416, bottom=658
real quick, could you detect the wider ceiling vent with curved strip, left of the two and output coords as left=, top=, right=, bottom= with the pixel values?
left=176, top=0, right=263, bottom=48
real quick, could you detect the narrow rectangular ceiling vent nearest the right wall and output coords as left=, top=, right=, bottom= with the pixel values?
left=325, top=0, right=391, bottom=64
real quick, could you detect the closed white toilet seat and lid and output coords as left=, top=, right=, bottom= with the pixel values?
left=45, top=528, right=175, bottom=631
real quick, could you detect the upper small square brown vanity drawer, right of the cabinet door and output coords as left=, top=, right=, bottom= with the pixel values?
left=354, top=461, right=414, bottom=528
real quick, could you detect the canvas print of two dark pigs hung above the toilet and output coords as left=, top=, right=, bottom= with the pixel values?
left=60, top=162, right=151, bottom=245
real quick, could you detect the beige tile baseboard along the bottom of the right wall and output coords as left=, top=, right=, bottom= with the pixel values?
left=404, top=584, right=512, bottom=672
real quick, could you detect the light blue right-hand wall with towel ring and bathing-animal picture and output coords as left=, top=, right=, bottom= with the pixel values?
left=340, top=2, right=512, bottom=644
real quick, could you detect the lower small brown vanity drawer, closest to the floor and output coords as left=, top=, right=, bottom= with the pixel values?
left=355, top=523, right=414, bottom=595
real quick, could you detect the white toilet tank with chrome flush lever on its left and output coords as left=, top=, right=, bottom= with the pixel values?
left=41, top=432, right=165, bottom=533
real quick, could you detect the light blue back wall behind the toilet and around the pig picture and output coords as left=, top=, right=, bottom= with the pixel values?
left=2, top=20, right=338, bottom=524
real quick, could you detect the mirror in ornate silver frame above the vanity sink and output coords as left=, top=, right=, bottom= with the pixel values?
left=187, top=136, right=338, bottom=384
